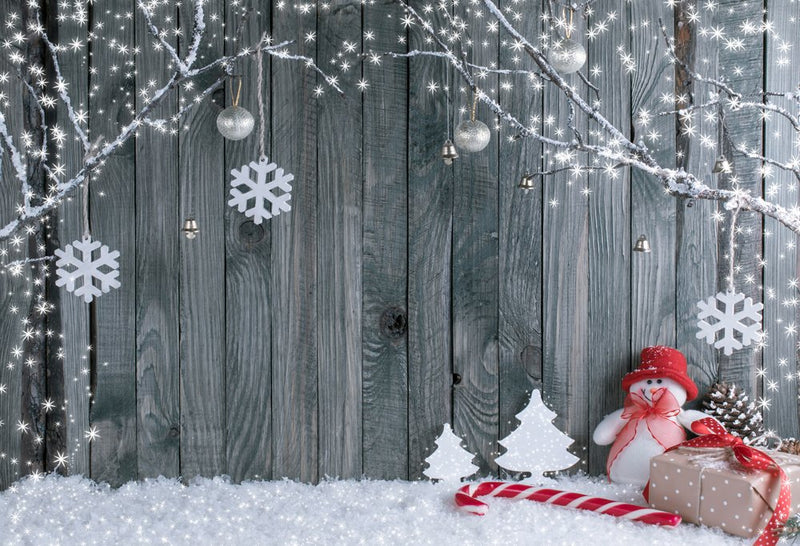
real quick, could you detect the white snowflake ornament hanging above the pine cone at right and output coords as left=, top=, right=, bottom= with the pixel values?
left=697, top=290, right=764, bottom=355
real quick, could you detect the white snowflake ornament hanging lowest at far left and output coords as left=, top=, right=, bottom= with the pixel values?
left=55, top=235, right=120, bottom=303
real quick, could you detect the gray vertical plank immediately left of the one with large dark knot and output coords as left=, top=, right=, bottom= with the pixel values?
left=317, top=0, right=363, bottom=478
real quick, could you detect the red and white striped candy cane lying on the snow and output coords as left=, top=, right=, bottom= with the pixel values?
left=456, top=482, right=681, bottom=527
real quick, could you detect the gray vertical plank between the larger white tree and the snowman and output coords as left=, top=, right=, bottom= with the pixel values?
left=542, top=5, right=591, bottom=470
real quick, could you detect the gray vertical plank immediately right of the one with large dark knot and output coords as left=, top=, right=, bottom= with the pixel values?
left=408, top=0, right=460, bottom=479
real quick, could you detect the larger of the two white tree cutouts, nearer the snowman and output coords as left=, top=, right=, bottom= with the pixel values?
left=495, top=390, right=579, bottom=478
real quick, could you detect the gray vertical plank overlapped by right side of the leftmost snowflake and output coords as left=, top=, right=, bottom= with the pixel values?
left=89, top=0, right=137, bottom=485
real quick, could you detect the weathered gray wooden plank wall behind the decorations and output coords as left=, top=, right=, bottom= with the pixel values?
left=0, top=0, right=800, bottom=487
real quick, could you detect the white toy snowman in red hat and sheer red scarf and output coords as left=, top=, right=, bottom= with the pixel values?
left=593, top=346, right=708, bottom=486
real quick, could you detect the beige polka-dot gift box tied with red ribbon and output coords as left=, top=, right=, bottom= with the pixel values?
left=645, top=416, right=800, bottom=544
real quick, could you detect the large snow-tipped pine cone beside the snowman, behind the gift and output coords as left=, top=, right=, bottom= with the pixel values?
left=700, top=382, right=767, bottom=446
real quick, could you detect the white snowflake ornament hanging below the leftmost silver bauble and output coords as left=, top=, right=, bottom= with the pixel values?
left=228, top=157, right=294, bottom=224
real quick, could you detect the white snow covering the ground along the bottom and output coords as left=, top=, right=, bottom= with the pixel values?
left=0, top=470, right=750, bottom=546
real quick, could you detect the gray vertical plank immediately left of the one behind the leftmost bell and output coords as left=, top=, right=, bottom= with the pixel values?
left=136, top=1, right=182, bottom=478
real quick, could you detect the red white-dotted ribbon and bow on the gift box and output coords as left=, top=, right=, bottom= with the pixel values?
left=645, top=417, right=792, bottom=546
